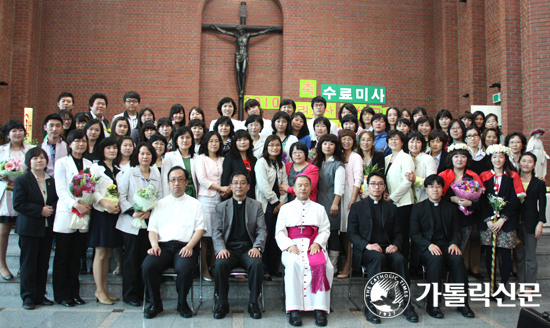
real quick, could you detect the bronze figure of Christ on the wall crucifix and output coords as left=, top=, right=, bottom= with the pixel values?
left=210, top=24, right=275, bottom=99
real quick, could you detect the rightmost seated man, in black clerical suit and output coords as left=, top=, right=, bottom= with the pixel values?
left=411, top=174, right=475, bottom=319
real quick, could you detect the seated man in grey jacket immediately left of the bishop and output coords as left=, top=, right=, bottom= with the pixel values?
left=212, top=172, right=267, bottom=319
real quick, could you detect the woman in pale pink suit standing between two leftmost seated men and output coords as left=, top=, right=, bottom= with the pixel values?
left=195, top=131, right=230, bottom=281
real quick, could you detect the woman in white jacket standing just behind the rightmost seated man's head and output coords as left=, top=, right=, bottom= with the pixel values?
left=405, top=131, right=437, bottom=203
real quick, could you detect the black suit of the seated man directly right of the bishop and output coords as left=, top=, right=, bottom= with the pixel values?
left=347, top=197, right=410, bottom=283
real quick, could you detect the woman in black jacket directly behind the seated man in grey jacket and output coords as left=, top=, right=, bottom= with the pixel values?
left=221, top=130, right=256, bottom=199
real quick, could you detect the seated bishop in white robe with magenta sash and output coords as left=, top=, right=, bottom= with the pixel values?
left=275, top=175, right=334, bottom=326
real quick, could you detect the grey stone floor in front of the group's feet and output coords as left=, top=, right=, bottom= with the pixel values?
left=0, top=296, right=550, bottom=328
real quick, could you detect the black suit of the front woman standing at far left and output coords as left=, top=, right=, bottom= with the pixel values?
left=13, top=171, right=57, bottom=304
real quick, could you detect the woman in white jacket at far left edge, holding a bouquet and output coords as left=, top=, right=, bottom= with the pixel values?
left=0, top=121, right=32, bottom=280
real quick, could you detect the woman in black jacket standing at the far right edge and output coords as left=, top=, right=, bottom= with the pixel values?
left=515, top=152, right=546, bottom=292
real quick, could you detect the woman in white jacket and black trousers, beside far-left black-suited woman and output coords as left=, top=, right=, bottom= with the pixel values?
left=53, top=130, right=92, bottom=307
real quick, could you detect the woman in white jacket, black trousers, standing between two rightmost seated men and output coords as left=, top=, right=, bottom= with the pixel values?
left=384, top=130, right=414, bottom=261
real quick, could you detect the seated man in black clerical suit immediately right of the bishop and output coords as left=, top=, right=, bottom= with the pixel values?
left=348, top=172, right=418, bottom=323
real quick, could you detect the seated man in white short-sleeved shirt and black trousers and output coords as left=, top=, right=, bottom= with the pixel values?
left=142, top=166, right=205, bottom=319
